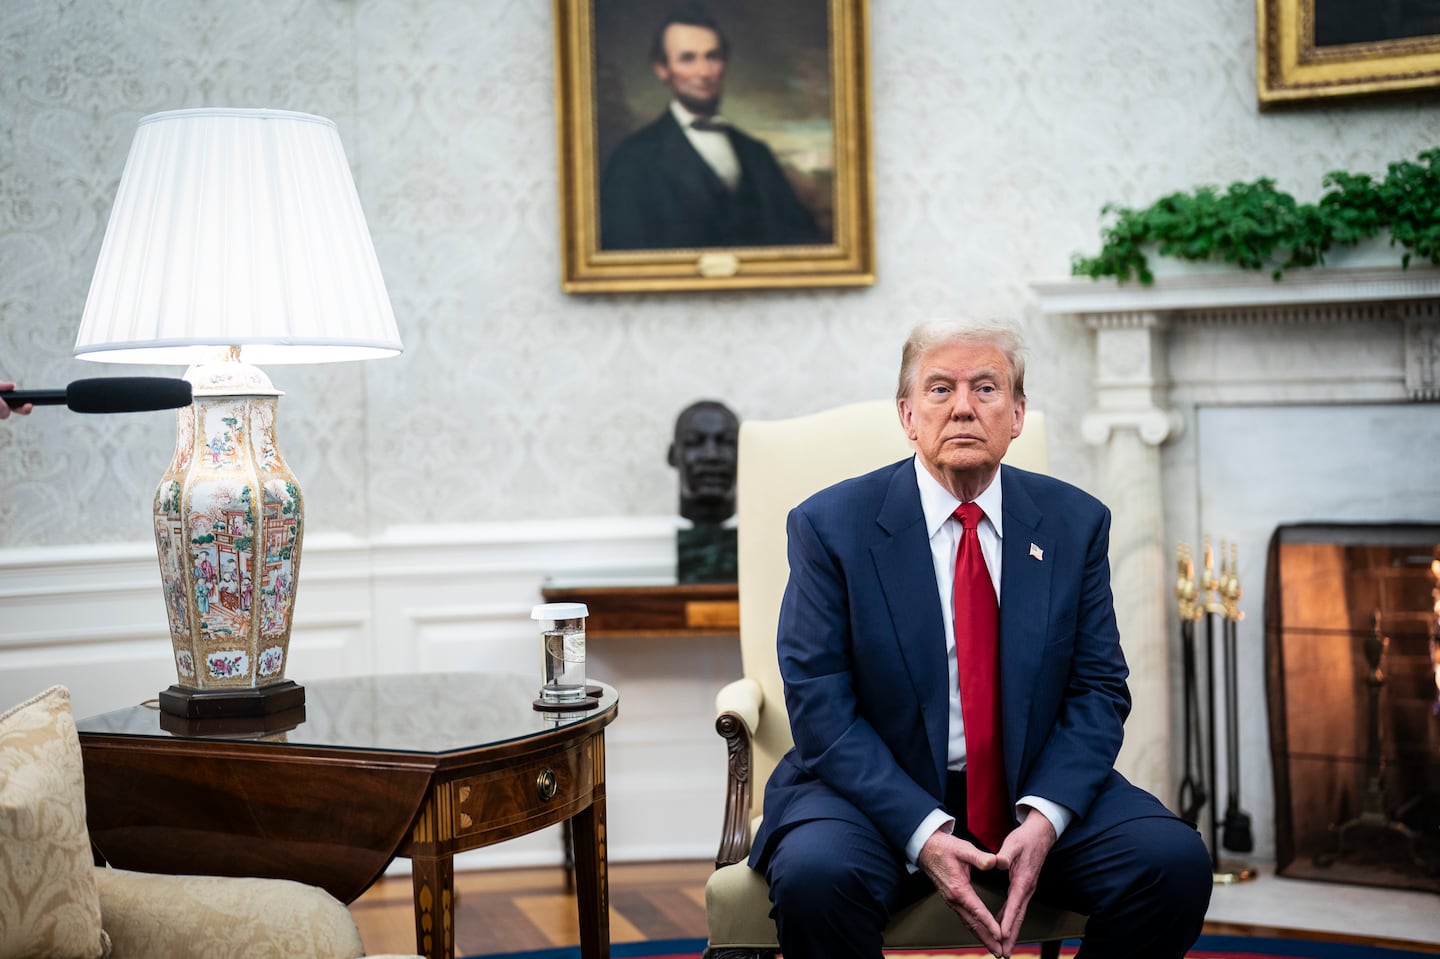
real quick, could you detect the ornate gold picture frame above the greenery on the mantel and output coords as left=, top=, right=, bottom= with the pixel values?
left=1256, top=0, right=1440, bottom=109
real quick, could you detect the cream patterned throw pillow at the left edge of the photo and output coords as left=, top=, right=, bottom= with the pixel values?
left=0, top=685, right=109, bottom=959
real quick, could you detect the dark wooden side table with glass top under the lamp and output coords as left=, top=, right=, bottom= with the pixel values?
left=76, top=672, right=619, bottom=959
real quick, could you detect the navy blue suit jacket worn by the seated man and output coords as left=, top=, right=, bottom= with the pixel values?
left=750, top=459, right=1172, bottom=870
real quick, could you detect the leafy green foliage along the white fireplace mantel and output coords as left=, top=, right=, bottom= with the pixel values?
left=1070, top=148, right=1440, bottom=285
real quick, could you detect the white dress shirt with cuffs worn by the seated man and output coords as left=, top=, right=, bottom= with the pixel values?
left=906, top=456, right=1074, bottom=871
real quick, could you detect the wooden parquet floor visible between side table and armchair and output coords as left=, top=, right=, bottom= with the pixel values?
left=350, top=863, right=714, bottom=956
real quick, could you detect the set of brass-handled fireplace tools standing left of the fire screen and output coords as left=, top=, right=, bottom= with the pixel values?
left=1175, top=534, right=1256, bottom=884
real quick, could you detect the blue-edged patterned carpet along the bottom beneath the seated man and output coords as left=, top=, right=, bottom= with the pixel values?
left=468, top=936, right=1434, bottom=959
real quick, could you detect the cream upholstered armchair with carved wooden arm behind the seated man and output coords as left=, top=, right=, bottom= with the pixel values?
left=706, top=400, right=1086, bottom=959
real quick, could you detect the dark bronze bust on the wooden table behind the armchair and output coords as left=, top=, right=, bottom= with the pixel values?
left=670, top=400, right=740, bottom=583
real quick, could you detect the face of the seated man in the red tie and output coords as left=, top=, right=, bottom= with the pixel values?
left=900, top=344, right=1025, bottom=500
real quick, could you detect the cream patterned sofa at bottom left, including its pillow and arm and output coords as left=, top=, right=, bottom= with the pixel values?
left=0, top=685, right=419, bottom=959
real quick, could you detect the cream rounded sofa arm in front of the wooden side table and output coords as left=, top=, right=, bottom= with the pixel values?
left=95, top=867, right=420, bottom=959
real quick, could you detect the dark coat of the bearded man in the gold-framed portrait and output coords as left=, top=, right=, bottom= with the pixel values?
left=600, top=109, right=822, bottom=251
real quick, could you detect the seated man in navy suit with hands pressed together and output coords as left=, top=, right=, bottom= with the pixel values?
left=750, top=323, right=1212, bottom=959
